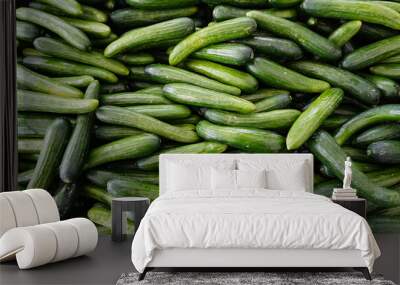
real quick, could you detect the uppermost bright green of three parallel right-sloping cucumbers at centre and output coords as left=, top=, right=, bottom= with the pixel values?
left=185, top=59, right=258, bottom=93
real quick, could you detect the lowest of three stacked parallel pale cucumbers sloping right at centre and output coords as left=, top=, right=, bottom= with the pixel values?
left=163, top=83, right=255, bottom=113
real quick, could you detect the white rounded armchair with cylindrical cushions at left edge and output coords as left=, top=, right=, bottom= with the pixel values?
left=0, top=189, right=98, bottom=269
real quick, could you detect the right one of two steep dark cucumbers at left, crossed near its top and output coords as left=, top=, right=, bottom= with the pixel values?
left=60, top=81, right=100, bottom=183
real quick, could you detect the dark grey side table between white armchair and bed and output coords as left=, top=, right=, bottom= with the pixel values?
left=111, top=197, right=150, bottom=241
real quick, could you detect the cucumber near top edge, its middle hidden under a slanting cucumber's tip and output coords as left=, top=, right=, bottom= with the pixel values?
left=213, top=5, right=297, bottom=22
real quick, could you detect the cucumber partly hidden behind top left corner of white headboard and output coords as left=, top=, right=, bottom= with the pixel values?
left=135, top=142, right=227, bottom=170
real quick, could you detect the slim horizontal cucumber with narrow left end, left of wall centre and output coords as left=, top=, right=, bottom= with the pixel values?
left=126, top=104, right=191, bottom=120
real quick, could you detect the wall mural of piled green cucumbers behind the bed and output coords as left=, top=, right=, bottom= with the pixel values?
left=16, top=0, right=400, bottom=233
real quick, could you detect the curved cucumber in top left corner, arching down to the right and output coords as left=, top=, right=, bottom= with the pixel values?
left=16, top=7, right=90, bottom=50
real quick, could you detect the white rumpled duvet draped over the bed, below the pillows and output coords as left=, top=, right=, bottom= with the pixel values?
left=132, top=189, right=380, bottom=272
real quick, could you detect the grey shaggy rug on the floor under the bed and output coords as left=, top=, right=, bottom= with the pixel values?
left=117, top=272, right=395, bottom=285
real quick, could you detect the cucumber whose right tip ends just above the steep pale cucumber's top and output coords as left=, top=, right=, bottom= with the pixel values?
left=247, top=57, right=330, bottom=93
